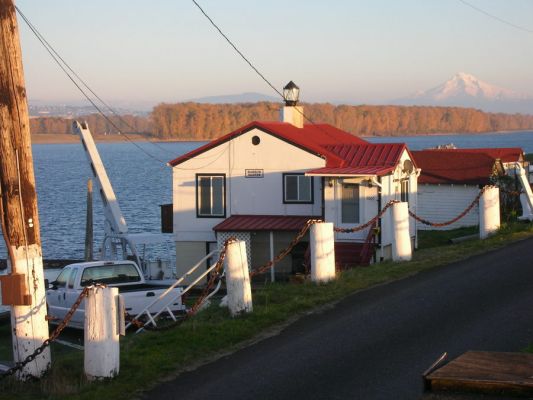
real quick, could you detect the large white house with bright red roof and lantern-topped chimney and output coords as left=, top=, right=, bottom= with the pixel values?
left=169, top=99, right=418, bottom=280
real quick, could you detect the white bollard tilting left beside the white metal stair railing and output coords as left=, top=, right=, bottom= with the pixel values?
left=222, top=240, right=253, bottom=316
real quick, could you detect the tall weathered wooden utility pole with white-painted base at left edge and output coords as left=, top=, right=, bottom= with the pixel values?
left=0, top=0, right=50, bottom=379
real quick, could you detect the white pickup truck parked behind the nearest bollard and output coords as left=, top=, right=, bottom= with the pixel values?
left=46, top=260, right=185, bottom=329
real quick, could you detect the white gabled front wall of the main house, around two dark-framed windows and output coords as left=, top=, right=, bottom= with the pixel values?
left=173, top=129, right=325, bottom=241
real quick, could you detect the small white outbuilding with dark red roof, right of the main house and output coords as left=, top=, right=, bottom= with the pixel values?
left=412, top=148, right=524, bottom=230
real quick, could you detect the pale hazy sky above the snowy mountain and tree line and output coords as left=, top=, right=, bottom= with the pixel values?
left=16, top=0, right=533, bottom=108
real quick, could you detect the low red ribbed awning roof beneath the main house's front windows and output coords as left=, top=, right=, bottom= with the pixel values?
left=213, top=215, right=314, bottom=232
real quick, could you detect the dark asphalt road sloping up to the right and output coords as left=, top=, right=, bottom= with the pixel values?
left=144, top=239, right=533, bottom=400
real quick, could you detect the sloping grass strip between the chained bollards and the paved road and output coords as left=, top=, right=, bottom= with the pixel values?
left=0, top=220, right=533, bottom=400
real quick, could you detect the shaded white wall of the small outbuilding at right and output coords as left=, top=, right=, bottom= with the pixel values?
left=417, top=184, right=480, bottom=230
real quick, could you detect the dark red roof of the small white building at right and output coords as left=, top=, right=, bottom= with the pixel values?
left=412, top=149, right=497, bottom=185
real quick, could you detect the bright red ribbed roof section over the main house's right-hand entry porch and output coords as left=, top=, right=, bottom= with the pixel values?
left=307, top=143, right=407, bottom=176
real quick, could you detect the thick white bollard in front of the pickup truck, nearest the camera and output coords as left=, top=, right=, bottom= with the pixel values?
left=84, top=287, right=120, bottom=380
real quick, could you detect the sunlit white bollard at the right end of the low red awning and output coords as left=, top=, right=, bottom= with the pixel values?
left=310, top=222, right=335, bottom=283
